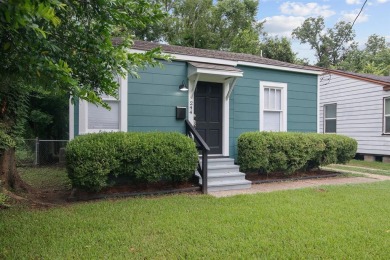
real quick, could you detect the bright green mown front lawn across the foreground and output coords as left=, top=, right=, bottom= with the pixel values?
left=0, top=181, right=390, bottom=259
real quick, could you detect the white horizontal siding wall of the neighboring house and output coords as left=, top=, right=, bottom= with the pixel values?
left=320, top=74, right=390, bottom=155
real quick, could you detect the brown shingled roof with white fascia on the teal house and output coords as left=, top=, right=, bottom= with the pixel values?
left=112, top=38, right=322, bottom=74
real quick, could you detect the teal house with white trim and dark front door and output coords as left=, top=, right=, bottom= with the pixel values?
left=69, top=41, right=322, bottom=158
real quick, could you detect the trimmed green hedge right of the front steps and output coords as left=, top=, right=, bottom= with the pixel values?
left=238, top=132, right=357, bottom=175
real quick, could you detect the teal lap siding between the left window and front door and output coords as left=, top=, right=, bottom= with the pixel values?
left=128, top=61, right=188, bottom=133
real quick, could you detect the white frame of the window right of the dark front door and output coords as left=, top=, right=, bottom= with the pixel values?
left=259, top=81, right=287, bottom=132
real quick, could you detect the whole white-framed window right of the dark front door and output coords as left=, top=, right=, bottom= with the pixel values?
left=260, top=82, right=287, bottom=132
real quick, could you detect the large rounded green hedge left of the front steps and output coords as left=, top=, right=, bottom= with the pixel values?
left=66, top=132, right=198, bottom=191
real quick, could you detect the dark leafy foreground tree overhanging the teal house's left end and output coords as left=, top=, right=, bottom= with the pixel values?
left=0, top=0, right=165, bottom=191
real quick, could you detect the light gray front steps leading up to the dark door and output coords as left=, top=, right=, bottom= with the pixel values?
left=197, top=157, right=252, bottom=192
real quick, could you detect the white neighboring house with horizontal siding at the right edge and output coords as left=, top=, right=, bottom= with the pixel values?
left=319, top=70, right=390, bottom=162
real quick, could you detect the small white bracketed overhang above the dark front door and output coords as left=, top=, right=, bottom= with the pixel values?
left=188, top=62, right=244, bottom=100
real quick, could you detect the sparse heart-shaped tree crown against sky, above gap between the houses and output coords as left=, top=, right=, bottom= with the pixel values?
left=292, top=16, right=355, bottom=68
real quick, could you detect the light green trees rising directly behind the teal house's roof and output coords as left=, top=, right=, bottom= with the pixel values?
left=131, top=0, right=296, bottom=63
